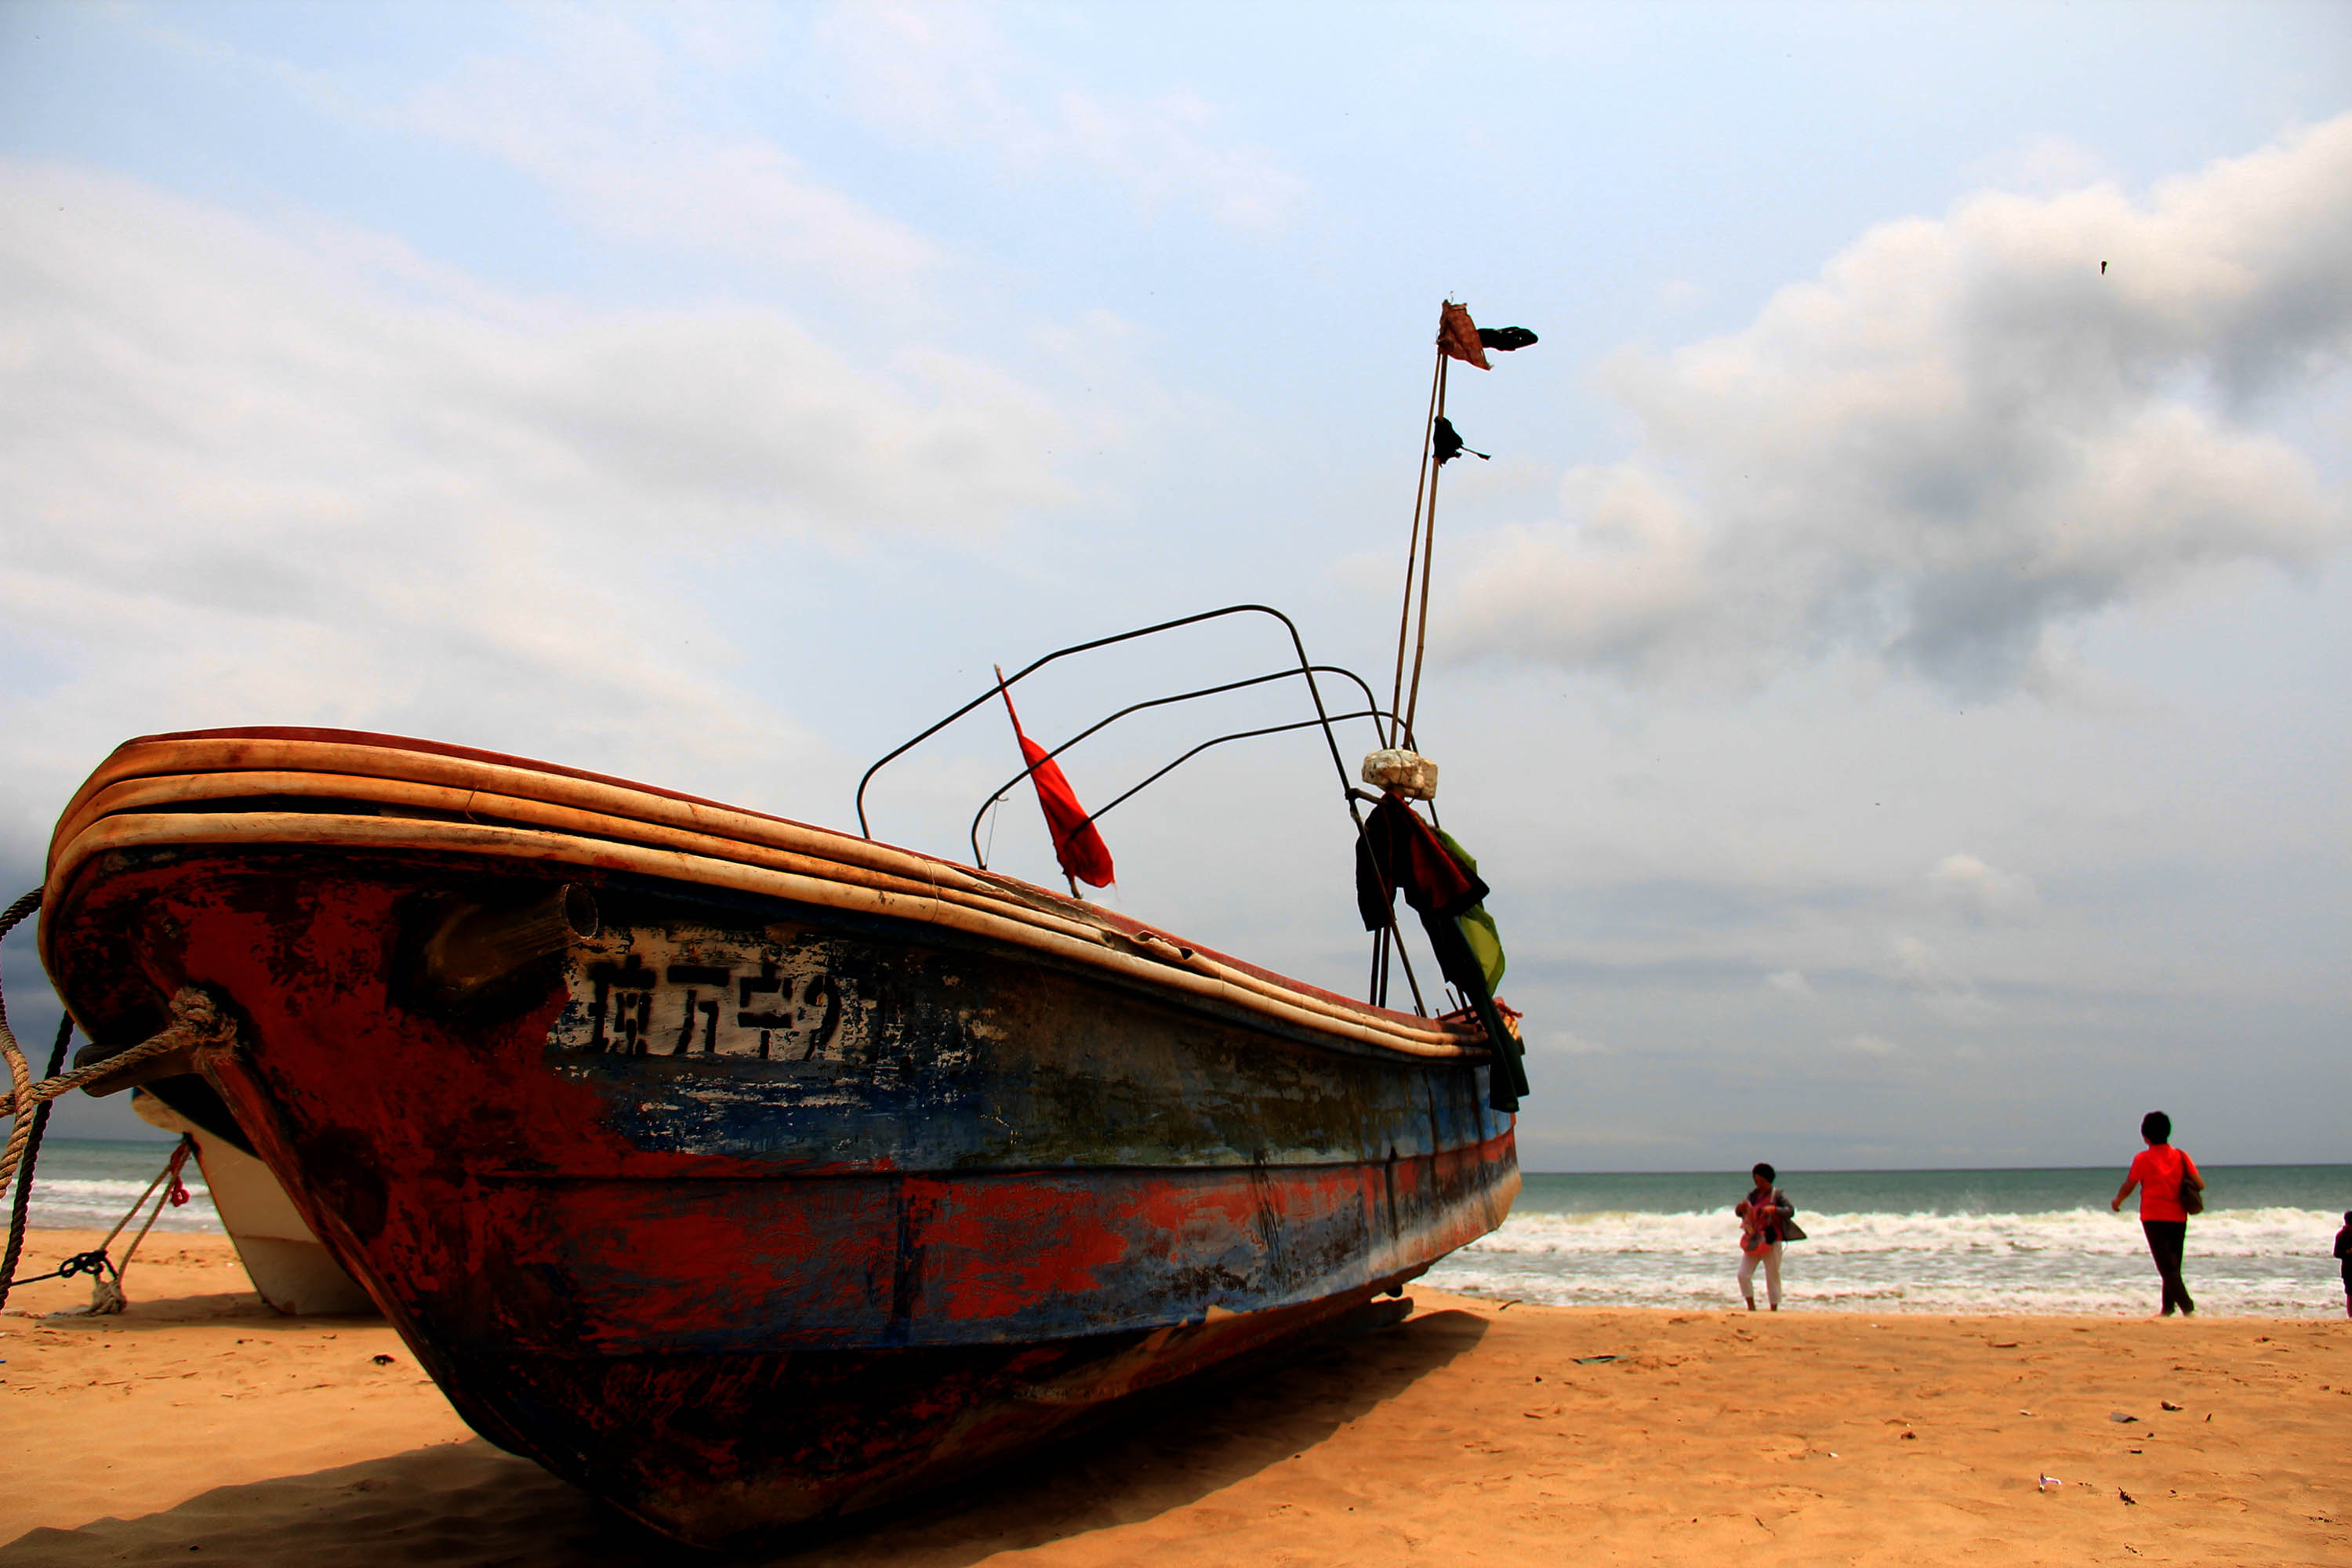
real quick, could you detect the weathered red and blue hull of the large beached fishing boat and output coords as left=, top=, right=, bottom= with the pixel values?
left=40, top=729, right=1519, bottom=1544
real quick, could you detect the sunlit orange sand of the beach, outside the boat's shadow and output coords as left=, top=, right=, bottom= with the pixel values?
left=0, top=1232, right=2352, bottom=1568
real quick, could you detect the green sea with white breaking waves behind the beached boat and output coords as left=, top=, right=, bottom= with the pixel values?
left=33, top=1138, right=2352, bottom=1316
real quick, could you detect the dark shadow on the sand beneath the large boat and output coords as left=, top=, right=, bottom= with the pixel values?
left=0, top=1309, right=1486, bottom=1568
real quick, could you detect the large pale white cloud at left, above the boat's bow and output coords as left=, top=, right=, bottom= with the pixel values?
left=0, top=162, right=1068, bottom=837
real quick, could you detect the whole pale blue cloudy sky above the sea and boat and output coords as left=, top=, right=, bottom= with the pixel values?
left=0, top=0, right=2352, bottom=1173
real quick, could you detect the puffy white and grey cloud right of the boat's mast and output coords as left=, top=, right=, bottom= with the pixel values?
left=1449, top=115, right=2352, bottom=696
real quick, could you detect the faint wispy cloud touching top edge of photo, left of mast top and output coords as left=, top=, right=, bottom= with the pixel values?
left=816, top=5, right=1308, bottom=230
